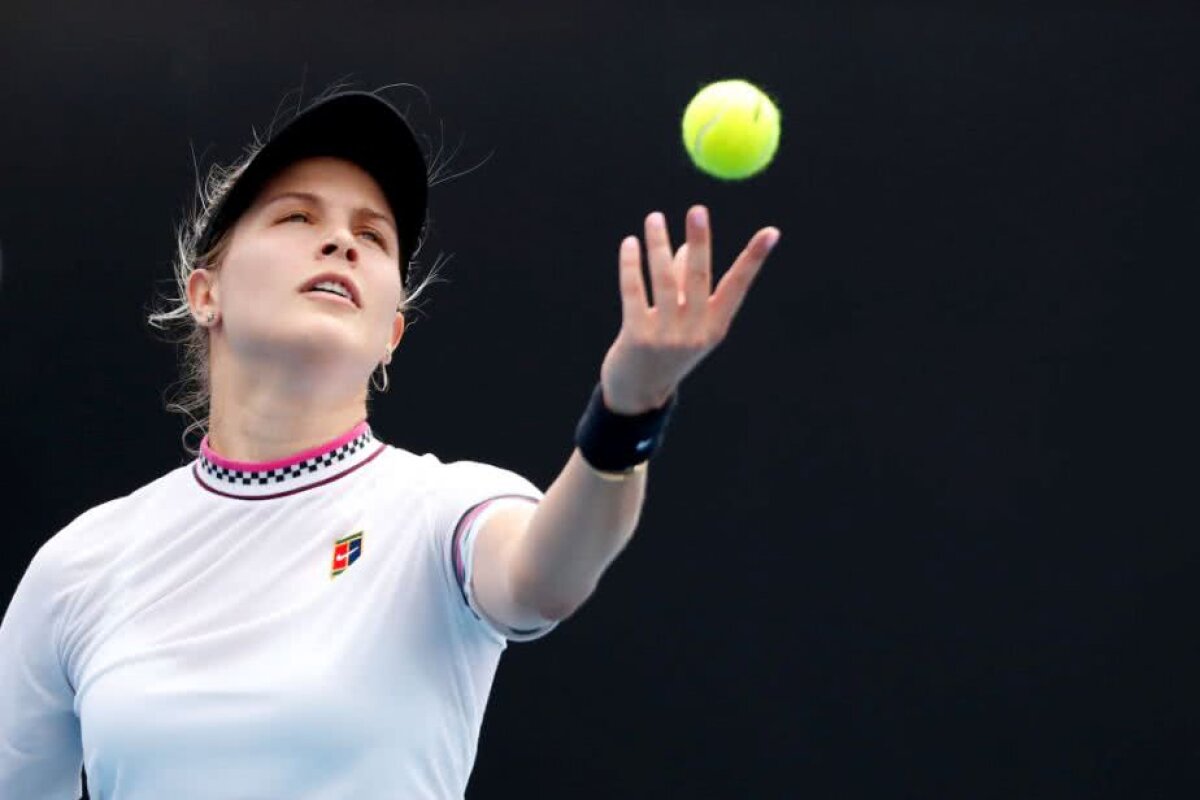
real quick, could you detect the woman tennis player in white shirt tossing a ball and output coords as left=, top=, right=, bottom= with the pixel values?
left=0, top=91, right=780, bottom=800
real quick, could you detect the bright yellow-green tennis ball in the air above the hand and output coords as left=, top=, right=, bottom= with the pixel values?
left=683, top=80, right=779, bottom=180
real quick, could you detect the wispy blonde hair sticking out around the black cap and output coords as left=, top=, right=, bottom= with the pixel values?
left=148, top=84, right=451, bottom=455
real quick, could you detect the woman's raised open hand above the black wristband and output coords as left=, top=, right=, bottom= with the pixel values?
left=600, top=205, right=780, bottom=415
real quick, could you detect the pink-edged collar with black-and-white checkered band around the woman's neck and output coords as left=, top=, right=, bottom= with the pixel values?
left=192, top=422, right=386, bottom=500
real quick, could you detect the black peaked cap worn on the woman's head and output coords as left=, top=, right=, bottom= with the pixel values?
left=196, top=91, right=428, bottom=282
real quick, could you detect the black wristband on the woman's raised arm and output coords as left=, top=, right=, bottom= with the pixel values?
left=575, top=384, right=676, bottom=473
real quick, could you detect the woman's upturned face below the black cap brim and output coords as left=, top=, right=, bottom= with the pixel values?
left=194, top=157, right=404, bottom=386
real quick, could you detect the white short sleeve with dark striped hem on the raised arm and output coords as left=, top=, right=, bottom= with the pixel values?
left=434, top=462, right=556, bottom=642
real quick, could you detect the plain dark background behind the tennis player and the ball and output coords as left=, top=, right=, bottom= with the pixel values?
left=0, top=0, right=1200, bottom=799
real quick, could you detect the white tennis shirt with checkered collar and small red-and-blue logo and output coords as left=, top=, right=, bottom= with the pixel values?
left=0, top=423, right=548, bottom=800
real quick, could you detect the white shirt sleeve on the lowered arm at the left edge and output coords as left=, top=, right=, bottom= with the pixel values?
left=0, top=545, right=83, bottom=800
